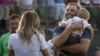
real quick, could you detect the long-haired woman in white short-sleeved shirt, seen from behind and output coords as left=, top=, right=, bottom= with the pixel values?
left=8, top=11, right=51, bottom=56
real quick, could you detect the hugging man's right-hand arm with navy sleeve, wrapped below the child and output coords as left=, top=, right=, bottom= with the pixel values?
left=62, top=29, right=92, bottom=53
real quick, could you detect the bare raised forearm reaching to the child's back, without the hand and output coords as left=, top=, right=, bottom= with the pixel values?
left=52, top=27, right=72, bottom=48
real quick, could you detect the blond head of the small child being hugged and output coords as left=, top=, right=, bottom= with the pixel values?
left=76, top=8, right=90, bottom=21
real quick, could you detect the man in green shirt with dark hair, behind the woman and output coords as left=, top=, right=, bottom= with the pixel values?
left=0, top=14, right=20, bottom=56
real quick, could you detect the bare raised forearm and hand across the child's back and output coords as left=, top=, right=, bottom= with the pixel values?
left=52, top=22, right=83, bottom=48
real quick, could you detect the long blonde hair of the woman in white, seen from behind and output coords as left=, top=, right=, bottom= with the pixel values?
left=16, top=11, right=40, bottom=43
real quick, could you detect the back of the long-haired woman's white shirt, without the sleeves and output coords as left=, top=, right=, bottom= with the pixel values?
left=9, top=33, right=41, bottom=56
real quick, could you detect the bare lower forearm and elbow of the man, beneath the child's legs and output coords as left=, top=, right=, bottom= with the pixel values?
left=62, top=38, right=90, bottom=53
